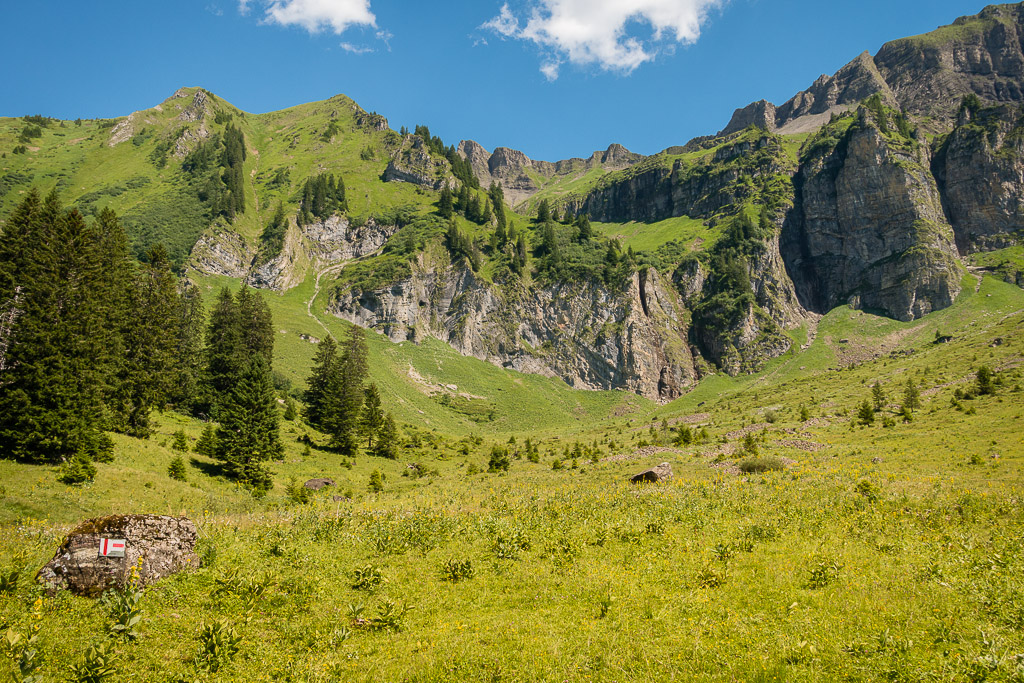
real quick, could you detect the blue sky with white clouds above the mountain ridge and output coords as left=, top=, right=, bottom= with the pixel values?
left=0, top=0, right=985, bottom=161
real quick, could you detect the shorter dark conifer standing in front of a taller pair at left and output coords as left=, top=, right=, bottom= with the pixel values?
left=216, top=355, right=285, bottom=494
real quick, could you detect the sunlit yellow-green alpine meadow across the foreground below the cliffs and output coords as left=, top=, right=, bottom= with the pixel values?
left=0, top=278, right=1024, bottom=681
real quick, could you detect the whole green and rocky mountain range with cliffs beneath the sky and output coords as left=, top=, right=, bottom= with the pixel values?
left=0, top=3, right=1024, bottom=401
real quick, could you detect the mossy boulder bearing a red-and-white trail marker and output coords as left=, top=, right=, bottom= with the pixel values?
left=36, top=515, right=200, bottom=597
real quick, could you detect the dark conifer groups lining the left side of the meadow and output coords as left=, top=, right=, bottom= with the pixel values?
left=0, top=190, right=397, bottom=494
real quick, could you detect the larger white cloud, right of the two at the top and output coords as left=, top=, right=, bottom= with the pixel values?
left=480, top=0, right=726, bottom=81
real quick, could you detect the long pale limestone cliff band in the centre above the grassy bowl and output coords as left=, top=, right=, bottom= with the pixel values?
left=328, top=259, right=696, bottom=400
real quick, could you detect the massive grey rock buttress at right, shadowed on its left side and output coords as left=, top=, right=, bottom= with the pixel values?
left=788, top=109, right=962, bottom=321
